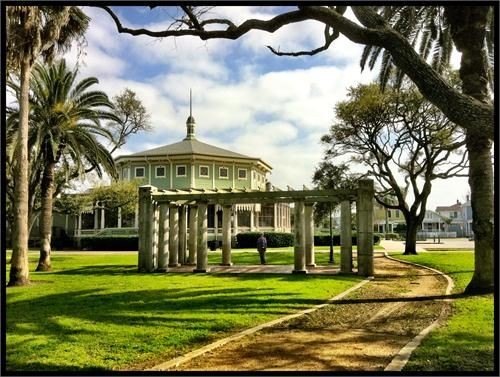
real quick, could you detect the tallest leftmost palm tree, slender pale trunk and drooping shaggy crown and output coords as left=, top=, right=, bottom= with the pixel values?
left=6, top=6, right=90, bottom=286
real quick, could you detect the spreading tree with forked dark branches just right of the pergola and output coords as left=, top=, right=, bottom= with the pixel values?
left=322, top=84, right=467, bottom=254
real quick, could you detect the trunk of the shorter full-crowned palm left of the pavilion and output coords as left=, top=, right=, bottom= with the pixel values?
left=36, top=162, right=56, bottom=271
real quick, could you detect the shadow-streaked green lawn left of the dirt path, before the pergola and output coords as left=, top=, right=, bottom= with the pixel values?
left=4, top=251, right=361, bottom=372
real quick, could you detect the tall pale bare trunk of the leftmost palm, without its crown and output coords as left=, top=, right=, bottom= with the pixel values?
left=8, top=57, right=31, bottom=286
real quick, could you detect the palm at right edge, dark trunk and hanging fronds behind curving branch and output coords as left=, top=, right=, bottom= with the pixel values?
left=361, top=5, right=495, bottom=293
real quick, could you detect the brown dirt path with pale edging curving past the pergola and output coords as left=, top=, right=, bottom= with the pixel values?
left=165, top=254, right=446, bottom=371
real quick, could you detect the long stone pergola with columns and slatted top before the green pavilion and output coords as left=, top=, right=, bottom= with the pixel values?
left=138, top=180, right=373, bottom=276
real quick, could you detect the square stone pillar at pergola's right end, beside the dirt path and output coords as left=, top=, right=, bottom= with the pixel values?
left=356, top=179, right=374, bottom=276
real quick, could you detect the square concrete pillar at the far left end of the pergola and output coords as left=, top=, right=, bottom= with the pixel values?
left=138, top=185, right=153, bottom=271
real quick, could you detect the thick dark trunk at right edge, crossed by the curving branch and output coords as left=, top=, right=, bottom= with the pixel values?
left=446, top=6, right=494, bottom=293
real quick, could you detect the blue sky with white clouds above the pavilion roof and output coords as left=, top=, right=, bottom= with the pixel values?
left=56, top=6, right=469, bottom=210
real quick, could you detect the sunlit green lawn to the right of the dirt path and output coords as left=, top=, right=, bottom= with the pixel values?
left=392, top=252, right=494, bottom=372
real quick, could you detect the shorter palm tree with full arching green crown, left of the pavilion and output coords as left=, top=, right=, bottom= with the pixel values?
left=11, top=60, right=118, bottom=271
